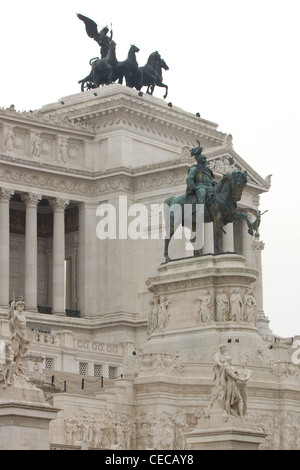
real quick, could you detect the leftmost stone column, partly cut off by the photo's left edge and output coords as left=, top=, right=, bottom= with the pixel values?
left=0, top=188, right=14, bottom=307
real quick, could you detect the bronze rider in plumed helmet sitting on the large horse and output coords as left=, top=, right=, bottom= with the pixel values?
left=186, top=140, right=217, bottom=204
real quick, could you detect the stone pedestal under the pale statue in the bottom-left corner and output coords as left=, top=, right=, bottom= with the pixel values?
left=0, top=378, right=58, bottom=450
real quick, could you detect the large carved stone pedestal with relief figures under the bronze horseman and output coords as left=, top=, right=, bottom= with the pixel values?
left=143, top=253, right=260, bottom=355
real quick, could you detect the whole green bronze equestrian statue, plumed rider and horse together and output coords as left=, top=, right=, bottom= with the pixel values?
left=164, top=140, right=253, bottom=262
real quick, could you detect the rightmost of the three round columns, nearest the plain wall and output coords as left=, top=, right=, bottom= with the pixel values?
left=49, top=198, right=69, bottom=315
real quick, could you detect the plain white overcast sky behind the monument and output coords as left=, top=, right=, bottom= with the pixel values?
left=0, top=0, right=300, bottom=336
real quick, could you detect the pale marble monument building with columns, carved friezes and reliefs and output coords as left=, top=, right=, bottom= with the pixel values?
left=0, top=84, right=300, bottom=449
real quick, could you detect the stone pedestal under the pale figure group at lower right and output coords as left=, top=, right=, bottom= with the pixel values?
left=185, top=411, right=266, bottom=450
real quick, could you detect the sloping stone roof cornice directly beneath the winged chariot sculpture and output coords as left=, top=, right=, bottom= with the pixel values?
left=39, top=84, right=226, bottom=146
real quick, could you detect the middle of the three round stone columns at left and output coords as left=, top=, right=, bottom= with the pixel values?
left=22, top=194, right=42, bottom=311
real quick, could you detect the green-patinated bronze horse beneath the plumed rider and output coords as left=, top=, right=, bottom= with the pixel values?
left=164, top=170, right=253, bottom=262
